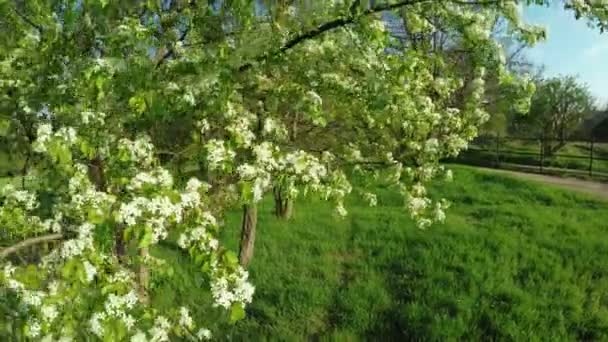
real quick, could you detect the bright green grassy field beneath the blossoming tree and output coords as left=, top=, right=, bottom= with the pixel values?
left=155, top=167, right=608, bottom=341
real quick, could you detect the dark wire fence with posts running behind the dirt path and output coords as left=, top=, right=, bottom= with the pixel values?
left=456, top=135, right=608, bottom=180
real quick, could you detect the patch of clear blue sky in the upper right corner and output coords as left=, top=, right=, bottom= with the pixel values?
left=524, top=4, right=608, bottom=104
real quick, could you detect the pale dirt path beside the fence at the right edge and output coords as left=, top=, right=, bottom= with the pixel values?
left=480, top=168, right=608, bottom=200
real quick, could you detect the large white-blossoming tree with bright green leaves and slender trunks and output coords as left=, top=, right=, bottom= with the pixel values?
left=0, top=0, right=608, bottom=341
